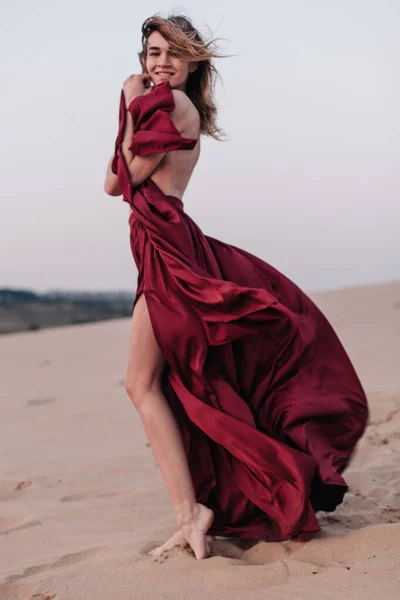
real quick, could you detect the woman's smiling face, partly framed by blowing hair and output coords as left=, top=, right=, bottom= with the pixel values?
left=145, top=31, right=197, bottom=91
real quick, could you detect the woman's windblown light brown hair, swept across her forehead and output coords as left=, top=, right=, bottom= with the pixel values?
left=139, top=15, right=224, bottom=139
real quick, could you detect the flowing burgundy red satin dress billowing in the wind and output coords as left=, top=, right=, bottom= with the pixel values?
left=113, top=82, right=368, bottom=541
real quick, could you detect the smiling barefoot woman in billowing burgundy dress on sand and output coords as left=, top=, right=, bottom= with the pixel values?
left=105, top=17, right=368, bottom=559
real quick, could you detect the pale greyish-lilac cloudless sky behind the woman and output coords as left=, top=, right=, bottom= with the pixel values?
left=0, top=0, right=400, bottom=291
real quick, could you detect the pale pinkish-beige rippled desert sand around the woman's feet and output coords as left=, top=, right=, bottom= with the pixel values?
left=0, top=282, right=400, bottom=600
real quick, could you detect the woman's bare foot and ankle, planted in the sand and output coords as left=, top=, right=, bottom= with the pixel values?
left=149, top=504, right=214, bottom=559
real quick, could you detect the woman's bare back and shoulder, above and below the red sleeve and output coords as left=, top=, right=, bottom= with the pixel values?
left=151, top=90, right=200, bottom=199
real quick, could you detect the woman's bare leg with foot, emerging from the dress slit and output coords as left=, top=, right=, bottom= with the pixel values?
left=125, top=294, right=213, bottom=558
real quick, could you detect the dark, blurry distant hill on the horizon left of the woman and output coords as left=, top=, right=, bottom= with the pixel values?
left=0, top=288, right=134, bottom=334
